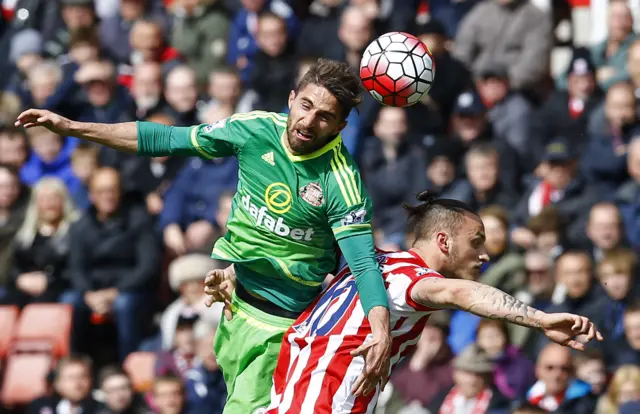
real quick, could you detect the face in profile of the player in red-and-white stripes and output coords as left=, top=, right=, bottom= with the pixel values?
left=445, top=214, right=489, bottom=280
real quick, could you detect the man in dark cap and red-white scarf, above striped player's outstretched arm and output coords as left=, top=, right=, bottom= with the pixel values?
left=511, top=137, right=600, bottom=247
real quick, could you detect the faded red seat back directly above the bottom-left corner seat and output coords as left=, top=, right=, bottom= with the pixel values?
left=13, top=303, right=73, bottom=358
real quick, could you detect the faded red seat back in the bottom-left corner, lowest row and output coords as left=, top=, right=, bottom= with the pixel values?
left=1, top=353, right=53, bottom=406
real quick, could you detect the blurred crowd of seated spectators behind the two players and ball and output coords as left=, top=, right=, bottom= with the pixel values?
left=0, top=0, right=640, bottom=414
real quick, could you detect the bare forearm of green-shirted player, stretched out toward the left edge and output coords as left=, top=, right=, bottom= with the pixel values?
left=69, top=121, right=138, bottom=153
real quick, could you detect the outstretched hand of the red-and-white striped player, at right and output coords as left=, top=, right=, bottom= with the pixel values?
left=540, top=313, right=603, bottom=351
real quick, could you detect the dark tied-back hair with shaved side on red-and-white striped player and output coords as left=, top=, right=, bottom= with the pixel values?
left=403, top=191, right=480, bottom=241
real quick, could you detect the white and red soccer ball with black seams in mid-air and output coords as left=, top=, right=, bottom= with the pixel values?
left=360, top=32, right=436, bottom=107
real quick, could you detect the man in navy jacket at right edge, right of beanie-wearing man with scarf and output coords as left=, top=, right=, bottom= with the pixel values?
left=580, top=82, right=640, bottom=193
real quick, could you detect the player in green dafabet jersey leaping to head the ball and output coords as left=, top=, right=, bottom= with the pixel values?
left=16, top=59, right=391, bottom=414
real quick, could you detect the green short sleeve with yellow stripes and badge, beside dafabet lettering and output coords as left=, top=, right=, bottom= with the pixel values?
left=327, top=147, right=372, bottom=240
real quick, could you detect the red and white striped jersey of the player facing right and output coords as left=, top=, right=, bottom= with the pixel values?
left=266, top=251, right=442, bottom=414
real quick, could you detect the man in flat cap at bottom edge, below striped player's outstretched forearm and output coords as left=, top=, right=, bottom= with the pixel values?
left=432, top=344, right=509, bottom=414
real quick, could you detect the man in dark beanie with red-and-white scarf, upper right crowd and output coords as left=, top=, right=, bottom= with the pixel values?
left=533, top=48, right=602, bottom=156
